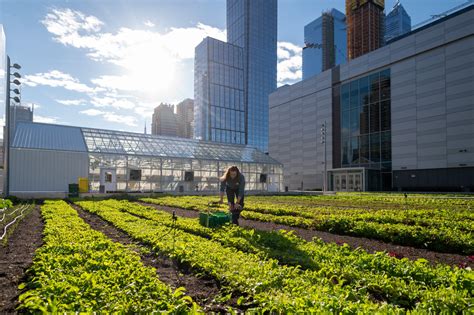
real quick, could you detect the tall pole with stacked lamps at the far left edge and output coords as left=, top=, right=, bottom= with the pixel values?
left=3, top=56, right=21, bottom=197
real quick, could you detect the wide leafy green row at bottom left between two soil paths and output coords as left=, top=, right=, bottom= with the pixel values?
left=20, top=201, right=197, bottom=313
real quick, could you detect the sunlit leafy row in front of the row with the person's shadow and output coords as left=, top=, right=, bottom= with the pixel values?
left=79, top=201, right=467, bottom=312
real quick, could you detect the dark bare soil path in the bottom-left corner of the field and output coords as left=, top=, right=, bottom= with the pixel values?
left=0, top=206, right=44, bottom=314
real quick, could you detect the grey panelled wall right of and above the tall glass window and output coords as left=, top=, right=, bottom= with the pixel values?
left=340, top=6, right=474, bottom=171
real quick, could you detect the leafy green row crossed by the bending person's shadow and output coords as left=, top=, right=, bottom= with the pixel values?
left=99, top=200, right=474, bottom=308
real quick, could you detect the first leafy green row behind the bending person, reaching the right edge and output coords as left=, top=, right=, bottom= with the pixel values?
left=140, top=197, right=474, bottom=255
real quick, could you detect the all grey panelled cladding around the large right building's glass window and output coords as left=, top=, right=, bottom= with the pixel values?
left=269, top=9, right=474, bottom=189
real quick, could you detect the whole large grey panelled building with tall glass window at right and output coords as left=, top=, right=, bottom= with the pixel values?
left=269, top=5, right=474, bottom=192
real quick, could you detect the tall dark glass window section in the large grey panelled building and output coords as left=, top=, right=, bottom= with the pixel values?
left=340, top=69, right=392, bottom=185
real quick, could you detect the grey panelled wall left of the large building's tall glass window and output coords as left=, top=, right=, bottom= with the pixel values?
left=269, top=70, right=332, bottom=190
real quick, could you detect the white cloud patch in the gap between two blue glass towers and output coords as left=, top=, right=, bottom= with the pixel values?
left=277, top=42, right=303, bottom=86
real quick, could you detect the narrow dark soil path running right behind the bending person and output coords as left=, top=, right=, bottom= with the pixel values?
left=138, top=202, right=474, bottom=268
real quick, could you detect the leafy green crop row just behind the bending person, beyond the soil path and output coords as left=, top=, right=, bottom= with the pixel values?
left=141, top=196, right=474, bottom=255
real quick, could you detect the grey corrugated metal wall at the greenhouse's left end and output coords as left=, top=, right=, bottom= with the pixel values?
left=10, top=148, right=89, bottom=196
